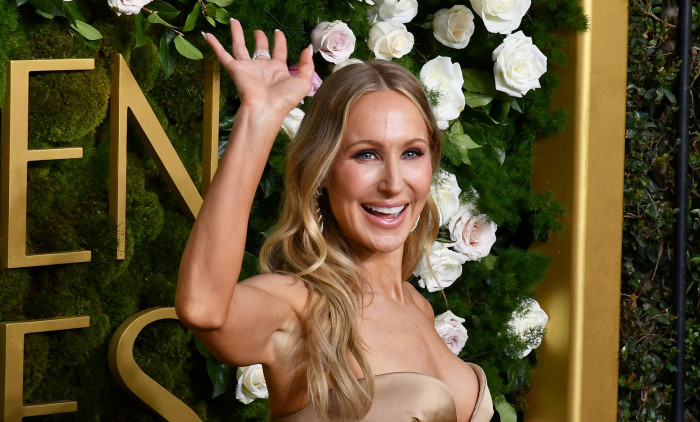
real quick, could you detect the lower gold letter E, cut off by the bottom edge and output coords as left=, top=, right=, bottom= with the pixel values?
left=0, top=316, right=90, bottom=422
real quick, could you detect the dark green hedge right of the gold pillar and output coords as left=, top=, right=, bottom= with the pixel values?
left=618, top=0, right=700, bottom=421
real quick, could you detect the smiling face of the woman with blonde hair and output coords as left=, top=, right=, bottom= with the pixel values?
left=326, top=91, right=433, bottom=252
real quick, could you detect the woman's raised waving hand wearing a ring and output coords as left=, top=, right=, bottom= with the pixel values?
left=204, top=19, right=314, bottom=118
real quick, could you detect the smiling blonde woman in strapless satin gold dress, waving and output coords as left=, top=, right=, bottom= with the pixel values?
left=176, top=20, right=493, bottom=422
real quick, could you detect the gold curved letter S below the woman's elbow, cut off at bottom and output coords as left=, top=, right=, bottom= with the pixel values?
left=109, top=308, right=202, bottom=422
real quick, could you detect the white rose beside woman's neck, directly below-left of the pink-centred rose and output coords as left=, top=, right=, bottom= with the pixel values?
left=413, top=242, right=466, bottom=292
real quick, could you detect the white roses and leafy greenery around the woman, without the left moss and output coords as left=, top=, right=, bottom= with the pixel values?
left=12, top=0, right=585, bottom=418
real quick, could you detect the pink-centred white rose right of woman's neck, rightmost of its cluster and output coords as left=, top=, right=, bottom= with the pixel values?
left=448, top=204, right=498, bottom=261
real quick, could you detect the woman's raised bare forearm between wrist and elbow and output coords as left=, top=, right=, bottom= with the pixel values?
left=176, top=108, right=284, bottom=329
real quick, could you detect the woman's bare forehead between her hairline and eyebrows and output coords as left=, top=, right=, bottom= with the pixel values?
left=343, top=91, right=429, bottom=142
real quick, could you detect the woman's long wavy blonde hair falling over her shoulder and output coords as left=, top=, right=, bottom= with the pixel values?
left=260, top=60, right=442, bottom=420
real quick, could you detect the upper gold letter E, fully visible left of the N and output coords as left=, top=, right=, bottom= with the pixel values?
left=0, top=59, right=95, bottom=268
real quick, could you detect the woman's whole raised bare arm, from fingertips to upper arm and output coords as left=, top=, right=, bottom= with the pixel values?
left=175, top=20, right=313, bottom=366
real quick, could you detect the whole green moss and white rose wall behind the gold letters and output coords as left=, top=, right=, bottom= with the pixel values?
left=0, top=0, right=586, bottom=421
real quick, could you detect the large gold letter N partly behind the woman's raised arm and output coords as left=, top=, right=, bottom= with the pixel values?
left=109, top=54, right=219, bottom=259
